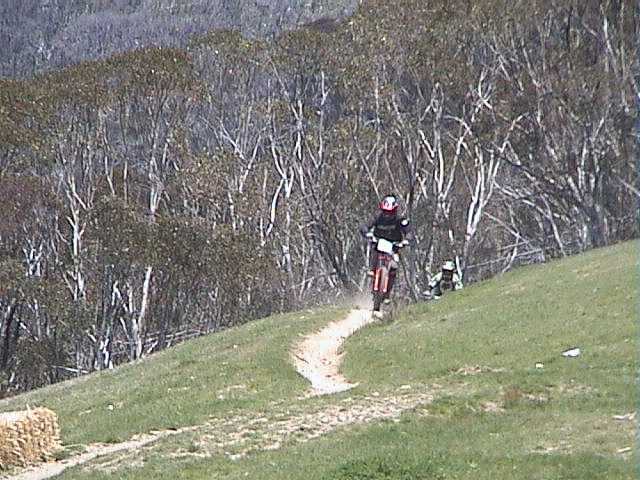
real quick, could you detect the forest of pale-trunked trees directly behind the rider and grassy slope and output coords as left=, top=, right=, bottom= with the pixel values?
left=0, top=0, right=640, bottom=395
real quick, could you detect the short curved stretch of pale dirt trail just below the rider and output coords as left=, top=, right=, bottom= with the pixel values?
left=293, top=310, right=374, bottom=395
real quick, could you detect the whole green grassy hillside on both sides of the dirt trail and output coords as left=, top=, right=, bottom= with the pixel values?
left=1, top=243, right=638, bottom=480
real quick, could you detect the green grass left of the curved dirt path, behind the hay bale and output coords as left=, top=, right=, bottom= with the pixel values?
left=0, top=308, right=346, bottom=444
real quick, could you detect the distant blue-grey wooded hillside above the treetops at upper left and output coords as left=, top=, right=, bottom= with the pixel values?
left=0, top=0, right=356, bottom=77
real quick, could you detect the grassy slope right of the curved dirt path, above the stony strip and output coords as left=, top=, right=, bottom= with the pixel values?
left=344, top=239, right=638, bottom=402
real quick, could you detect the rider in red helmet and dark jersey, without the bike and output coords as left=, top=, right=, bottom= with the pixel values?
left=360, top=195, right=411, bottom=301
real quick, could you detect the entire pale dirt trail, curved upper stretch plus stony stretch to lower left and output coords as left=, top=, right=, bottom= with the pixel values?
left=0, top=310, right=390, bottom=480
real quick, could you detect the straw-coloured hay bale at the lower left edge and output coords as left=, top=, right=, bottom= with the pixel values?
left=0, top=408, right=60, bottom=469
